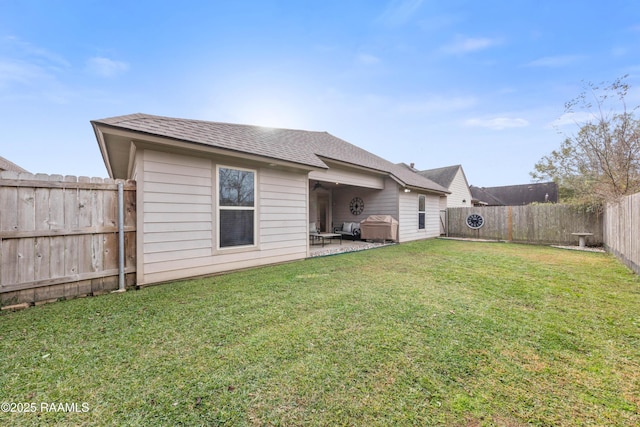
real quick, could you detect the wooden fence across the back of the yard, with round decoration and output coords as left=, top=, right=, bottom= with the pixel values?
left=447, top=204, right=603, bottom=245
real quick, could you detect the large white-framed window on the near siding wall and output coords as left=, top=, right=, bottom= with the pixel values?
left=218, top=167, right=256, bottom=248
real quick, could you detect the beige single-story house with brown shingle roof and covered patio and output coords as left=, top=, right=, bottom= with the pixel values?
left=91, top=114, right=448, bottom=285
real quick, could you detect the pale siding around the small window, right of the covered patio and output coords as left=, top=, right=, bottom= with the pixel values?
left=398, top=191, right=440, bottom=242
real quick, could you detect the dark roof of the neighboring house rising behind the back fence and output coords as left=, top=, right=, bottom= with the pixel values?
left=470, top=182, right=558, bottom=206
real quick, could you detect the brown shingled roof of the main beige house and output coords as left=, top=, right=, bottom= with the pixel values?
left=91, top=113, right=448, bottom=193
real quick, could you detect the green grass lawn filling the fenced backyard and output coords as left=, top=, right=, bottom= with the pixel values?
left=0, top=240, right=640, bottom=426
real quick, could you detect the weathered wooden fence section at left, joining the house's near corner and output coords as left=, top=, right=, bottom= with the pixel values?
left=0, top=172, right=136, bottom=306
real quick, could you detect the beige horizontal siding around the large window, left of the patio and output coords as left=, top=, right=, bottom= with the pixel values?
left=136, top=150, right=308, bottom=285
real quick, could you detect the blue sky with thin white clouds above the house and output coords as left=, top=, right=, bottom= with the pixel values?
left=0, top=0, right=640, bottom=186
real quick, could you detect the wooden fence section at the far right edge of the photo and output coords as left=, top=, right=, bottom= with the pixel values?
left=604, top=193, right=640, bottom=274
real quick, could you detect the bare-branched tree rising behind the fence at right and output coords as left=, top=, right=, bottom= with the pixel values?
left=531, top=75, right=640, bottom=208
